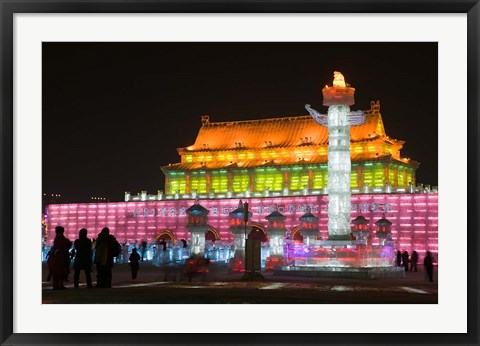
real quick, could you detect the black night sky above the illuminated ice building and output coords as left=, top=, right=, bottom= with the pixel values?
left=42, top=43, right=438, bottom=202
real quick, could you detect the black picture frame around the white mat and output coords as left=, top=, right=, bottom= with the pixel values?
left=0, top=0, right=480, bottom=345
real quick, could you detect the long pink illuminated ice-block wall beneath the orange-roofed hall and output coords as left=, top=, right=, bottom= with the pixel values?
left=48, top=194, right=438, bottom=258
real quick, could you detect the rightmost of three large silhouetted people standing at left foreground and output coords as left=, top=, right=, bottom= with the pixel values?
left=95, top=227, right=120, bottom=288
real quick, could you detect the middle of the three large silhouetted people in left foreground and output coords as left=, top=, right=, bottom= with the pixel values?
left=73, top=228, right=93, bottom=288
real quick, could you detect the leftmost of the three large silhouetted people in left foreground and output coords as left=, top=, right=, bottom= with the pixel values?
left=47, top=226, right=72, bottom=290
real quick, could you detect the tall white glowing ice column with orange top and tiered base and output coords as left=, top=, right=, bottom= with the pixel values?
left=274, top=72, right=405, bottom=278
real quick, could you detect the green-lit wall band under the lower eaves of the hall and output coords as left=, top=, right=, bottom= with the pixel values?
left=166, top=161, right=415, bottom=194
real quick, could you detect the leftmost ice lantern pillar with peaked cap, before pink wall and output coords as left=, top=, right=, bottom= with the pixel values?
left=187, top=199, right=210, bottom=257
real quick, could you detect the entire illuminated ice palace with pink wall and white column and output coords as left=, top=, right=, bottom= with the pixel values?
left=48, top=73, right=438, bottom=276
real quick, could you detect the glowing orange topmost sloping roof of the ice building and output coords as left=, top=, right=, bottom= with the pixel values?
left=178, top=102, right=396, bottom=154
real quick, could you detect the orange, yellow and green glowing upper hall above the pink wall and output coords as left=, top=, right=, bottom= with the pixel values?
left=161, top=96, right=417, bottom=200
